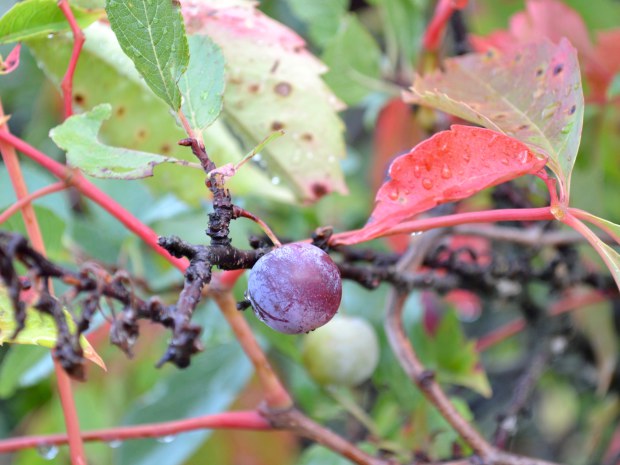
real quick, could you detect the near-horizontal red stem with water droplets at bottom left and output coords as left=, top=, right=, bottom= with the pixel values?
left=0, top=410, right=272, bottom=453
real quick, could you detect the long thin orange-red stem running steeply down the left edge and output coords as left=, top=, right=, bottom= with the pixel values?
left=0, top=102, right=86, bottom=465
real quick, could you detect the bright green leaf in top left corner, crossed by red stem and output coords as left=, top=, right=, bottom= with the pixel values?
left=0, top=0, right=103, bottom=44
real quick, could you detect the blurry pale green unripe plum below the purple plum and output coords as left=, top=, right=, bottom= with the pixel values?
left=303, top=315, right=379, bottom=386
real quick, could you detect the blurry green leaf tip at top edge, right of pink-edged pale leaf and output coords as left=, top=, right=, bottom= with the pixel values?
left=288, top=0, right=349, bottom=47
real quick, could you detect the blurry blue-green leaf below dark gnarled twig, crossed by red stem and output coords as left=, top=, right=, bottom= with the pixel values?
left=114, top=304, right=253, bottom=465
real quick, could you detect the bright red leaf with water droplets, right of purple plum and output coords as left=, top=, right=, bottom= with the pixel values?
left=346, top=125, right=546, bottom=243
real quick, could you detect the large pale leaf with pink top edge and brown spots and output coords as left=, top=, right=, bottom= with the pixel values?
left=184, top=0, right=346, bottom=201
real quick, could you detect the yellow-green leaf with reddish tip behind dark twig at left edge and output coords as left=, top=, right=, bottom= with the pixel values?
left=0, top=284, right=105, bottom=369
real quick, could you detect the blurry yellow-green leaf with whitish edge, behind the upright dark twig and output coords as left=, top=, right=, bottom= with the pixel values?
left=28, top=23, right=293, bottom=203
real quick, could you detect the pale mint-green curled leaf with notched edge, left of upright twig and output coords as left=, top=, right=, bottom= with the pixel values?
left=50, top=104, right=194, bottom=179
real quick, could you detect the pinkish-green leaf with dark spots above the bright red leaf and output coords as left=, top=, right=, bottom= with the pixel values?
left=408, top=39, right=583, bottom=195
